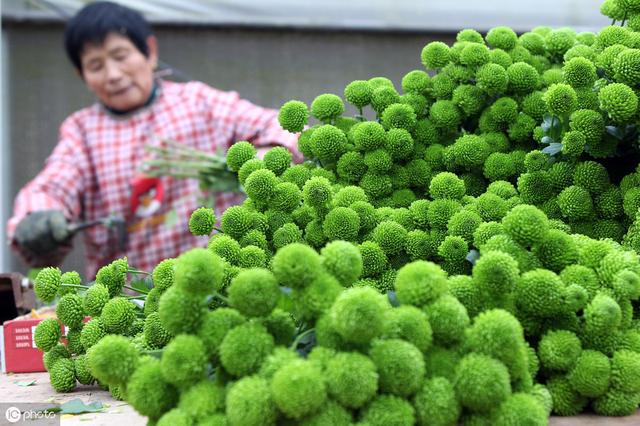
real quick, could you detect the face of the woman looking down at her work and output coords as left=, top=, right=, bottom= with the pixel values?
left=80, top=33, right=158, bottom=111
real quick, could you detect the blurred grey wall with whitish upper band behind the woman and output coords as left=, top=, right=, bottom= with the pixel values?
left=0, top=0, right=609, bottom=279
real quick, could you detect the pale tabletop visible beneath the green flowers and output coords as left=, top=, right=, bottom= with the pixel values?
left=0, top=373, right=640, bottom=426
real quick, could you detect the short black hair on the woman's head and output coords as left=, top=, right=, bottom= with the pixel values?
left=64, top=1, right=153, bottom=71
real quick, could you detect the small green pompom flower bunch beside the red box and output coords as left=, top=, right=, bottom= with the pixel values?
left=34, top=258, right=153, bottom=397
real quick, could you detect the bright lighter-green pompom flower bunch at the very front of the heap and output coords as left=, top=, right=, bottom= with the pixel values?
left=55, top=240, right=552, bottom=425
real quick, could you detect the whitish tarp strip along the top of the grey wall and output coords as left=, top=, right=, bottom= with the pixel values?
left=2, top=0, right=607, bottom=31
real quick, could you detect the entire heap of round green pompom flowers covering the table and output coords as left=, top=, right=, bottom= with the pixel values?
left=30, top=0, right=640, bottom=425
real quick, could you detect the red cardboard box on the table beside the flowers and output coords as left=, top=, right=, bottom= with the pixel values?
left=0, top=318, right=46, bottom=373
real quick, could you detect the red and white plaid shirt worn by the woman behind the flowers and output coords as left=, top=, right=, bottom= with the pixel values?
left=7, top=81, right=301, bottom=279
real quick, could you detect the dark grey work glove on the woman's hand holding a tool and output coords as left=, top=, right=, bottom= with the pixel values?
left=14, top=210, right=71, bottom=257
